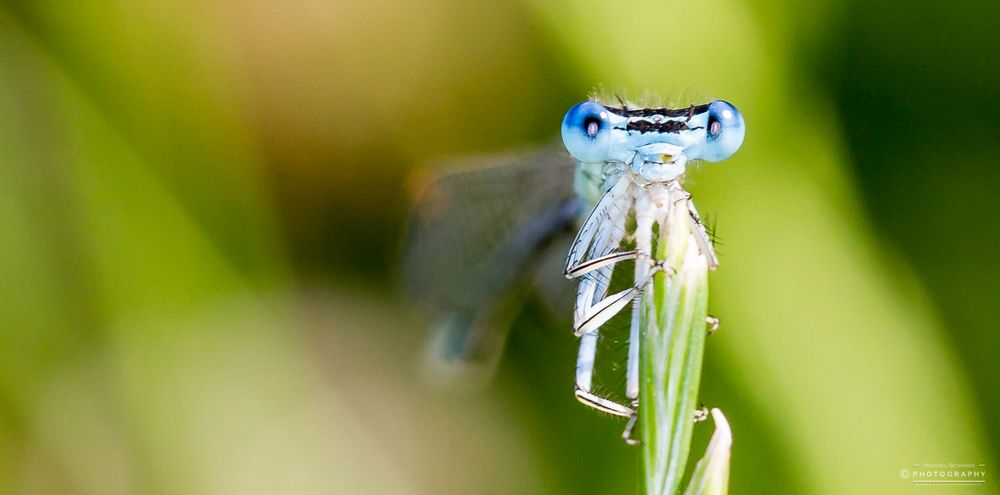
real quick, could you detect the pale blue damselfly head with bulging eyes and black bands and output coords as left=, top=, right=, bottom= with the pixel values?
left=562, top=100, right=746, bottom=181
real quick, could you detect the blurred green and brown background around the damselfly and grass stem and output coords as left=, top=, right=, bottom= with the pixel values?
left=0, top=0, right=1000, bottom=494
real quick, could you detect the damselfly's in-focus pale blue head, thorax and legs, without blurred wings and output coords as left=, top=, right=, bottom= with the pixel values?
left=562, top=100, right=746, bottom=443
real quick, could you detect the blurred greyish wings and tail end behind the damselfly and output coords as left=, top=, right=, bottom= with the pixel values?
left=402, top=146, right=580, bottom=388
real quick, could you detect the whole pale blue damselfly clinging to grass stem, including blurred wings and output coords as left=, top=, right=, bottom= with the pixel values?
left=404, top=100, right=745, bottom=437
